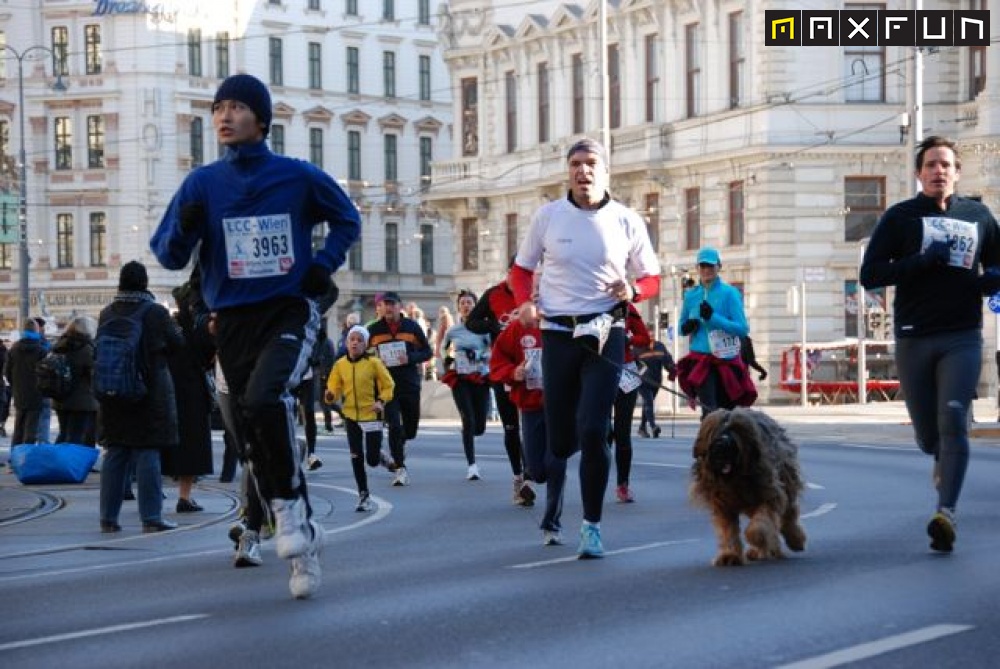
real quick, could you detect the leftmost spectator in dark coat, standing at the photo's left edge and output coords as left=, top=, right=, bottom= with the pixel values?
left=3, top=319, right=46, bottom=446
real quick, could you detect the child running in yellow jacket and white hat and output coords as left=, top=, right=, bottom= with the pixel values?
left=323, top=325, right=396, bottom=512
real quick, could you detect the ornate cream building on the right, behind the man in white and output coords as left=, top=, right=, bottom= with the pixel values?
left=426, top=0, right=1000, bottom=396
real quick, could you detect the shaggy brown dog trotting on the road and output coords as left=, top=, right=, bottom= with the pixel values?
left=690, top=409, right=806, bottom=567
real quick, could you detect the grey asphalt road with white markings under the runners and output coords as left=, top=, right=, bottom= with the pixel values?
left=0, top=412, right=1000, bottom=669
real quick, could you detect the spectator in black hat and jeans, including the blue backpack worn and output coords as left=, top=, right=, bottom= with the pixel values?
left=94, top=260, right=184, bottom=532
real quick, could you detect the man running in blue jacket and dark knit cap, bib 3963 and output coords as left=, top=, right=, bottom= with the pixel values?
left=150, top=74, right=361, bottom=598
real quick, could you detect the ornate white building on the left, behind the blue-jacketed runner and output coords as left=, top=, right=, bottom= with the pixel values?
left=0, top=0, right=453, bottom=331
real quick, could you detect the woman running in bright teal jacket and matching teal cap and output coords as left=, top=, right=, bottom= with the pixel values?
left=677, top=247, right=757, bottom=418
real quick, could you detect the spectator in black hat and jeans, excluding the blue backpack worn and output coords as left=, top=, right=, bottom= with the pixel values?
left=98, top=261, right=184, bottom=532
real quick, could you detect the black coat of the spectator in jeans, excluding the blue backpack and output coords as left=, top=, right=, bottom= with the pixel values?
left=98, top=292, right=184, bottom=448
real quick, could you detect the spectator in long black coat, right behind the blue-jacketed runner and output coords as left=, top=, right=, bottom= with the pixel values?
left=162, top=266, right=215, bottom=513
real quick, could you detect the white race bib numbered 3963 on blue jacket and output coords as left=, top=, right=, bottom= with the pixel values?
left=222, top=214, right=295, bottom=279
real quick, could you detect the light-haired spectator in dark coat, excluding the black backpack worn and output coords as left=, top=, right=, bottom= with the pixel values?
left=52, top=316, right=98, bottom=446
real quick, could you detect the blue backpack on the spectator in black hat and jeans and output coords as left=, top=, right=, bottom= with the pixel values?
left=94, top=302, right=154, bottom=402
